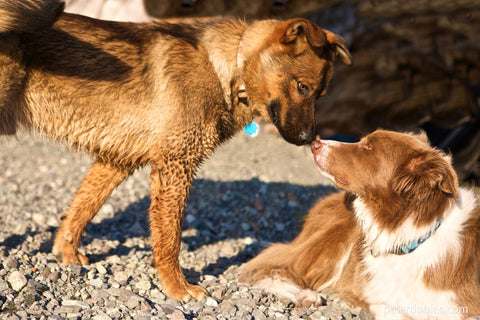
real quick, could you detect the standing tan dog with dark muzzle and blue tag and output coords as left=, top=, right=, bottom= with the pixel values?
left=0, top=0, right=351, bottom=300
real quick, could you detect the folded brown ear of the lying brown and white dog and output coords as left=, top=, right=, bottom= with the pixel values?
left=393, top=150, right=458, bottom=198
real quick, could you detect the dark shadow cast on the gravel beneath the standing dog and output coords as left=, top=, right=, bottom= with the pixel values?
left=0, top=179, right=335, bottom=282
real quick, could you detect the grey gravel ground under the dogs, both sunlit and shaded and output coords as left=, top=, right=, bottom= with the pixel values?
left=0, top=133, right=371, bottom=320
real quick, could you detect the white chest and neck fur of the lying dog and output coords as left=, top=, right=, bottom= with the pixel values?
left=355, top=189, right=476, bottom=319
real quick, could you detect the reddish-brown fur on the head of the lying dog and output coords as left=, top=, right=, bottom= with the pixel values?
left=314, top=130, right=458, bottom=230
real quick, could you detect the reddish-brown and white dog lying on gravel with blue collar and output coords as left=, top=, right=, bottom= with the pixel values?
left=241, top=131, right=480, bottom=319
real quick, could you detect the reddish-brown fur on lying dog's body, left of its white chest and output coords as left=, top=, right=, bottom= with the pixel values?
left=242, top=192, right=365, bottom=306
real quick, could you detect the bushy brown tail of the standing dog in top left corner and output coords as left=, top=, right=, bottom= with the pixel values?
left=0, top=0, right=65, bottom=33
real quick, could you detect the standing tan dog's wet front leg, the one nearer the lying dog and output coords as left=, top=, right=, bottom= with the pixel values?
left=149, top=160, right=206, bottom=301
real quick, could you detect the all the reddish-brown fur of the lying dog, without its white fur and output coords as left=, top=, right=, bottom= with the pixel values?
left=240, top=130, right=480, bottom=317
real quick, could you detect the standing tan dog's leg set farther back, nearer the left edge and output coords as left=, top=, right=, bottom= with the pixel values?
left=53, top=161, right=133, bottom=265
